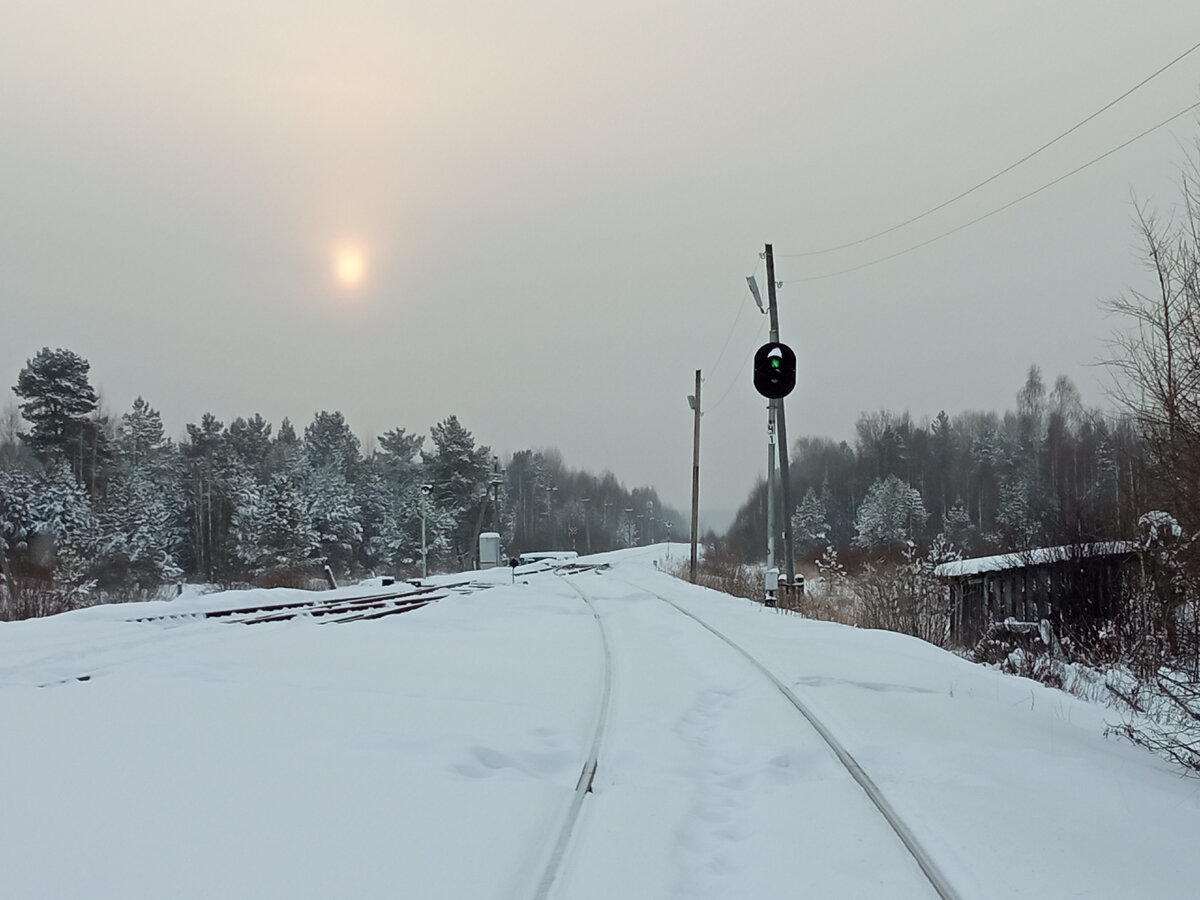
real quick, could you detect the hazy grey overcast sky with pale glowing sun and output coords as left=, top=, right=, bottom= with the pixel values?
left=7, top=0, right=1200, bottom=520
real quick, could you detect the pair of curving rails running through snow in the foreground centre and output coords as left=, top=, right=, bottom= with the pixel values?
left=534, top=571, right=960, bottom=900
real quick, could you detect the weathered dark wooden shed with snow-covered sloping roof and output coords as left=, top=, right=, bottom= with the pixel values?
left=935, top=541, right=1138, bottom=646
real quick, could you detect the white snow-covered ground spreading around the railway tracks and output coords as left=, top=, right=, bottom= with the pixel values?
left=0, top=545, right=1200, bottom=900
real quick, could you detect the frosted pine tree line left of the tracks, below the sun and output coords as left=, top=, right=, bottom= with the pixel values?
left=0, top=348, right=684, bottom=601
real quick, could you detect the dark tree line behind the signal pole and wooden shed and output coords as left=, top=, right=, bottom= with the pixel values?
left=726, top=366, right=1146, bottom=560
